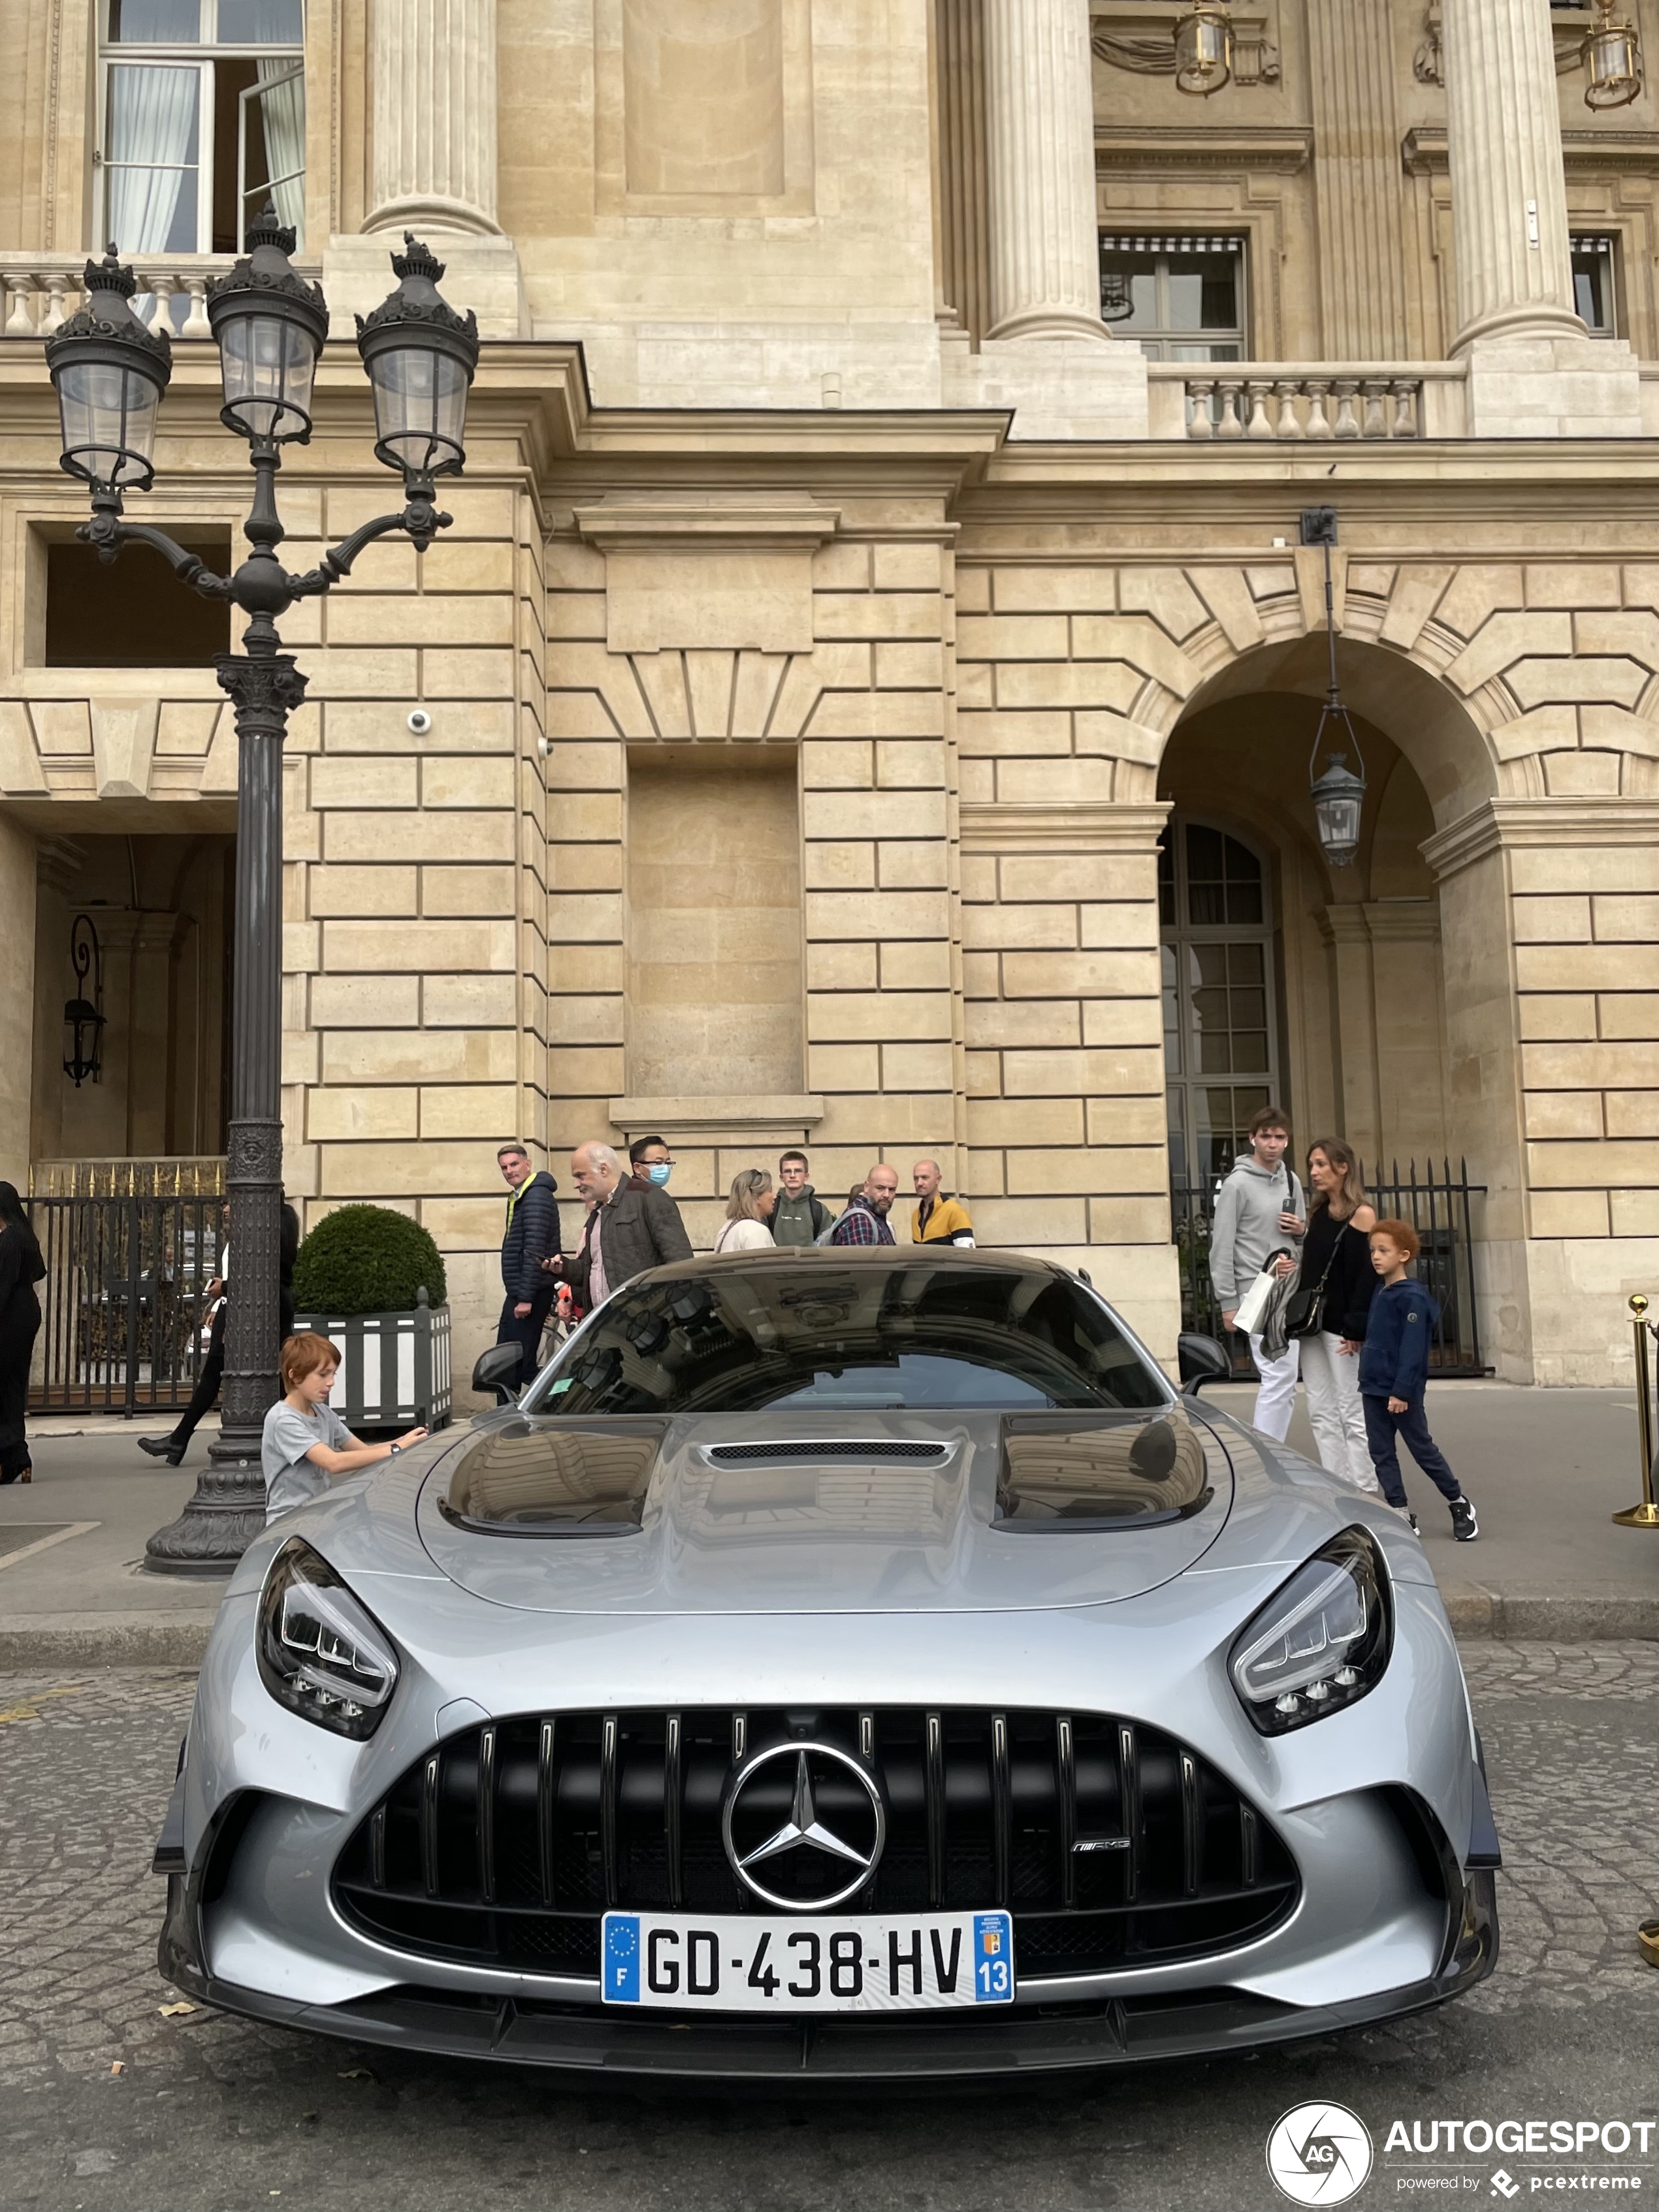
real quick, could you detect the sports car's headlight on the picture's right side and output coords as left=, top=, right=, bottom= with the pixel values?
left=1228, top=1529, right=1394, bottom=1736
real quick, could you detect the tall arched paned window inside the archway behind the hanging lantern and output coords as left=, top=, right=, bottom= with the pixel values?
left=1157, top=814, right=1287, bottom=1188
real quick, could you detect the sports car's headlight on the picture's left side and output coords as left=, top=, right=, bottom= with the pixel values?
left=257, top=1537, right=398, bottom=1743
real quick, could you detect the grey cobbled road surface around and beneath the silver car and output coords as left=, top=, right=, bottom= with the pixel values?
left=0, top=1644, right=1659, bottom=2212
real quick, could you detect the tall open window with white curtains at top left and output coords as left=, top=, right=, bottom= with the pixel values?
left=97, top=0, right=305, bottom=254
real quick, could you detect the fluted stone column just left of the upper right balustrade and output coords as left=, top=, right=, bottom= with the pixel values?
left=984, top=0, right=1110, bottom=338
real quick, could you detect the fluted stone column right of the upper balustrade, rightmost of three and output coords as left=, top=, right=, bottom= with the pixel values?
left=1442, top=0, right=1584, bottom=356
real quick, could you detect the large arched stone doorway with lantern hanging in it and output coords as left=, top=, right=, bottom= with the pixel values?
left=1157, top=640, right=1520, bottom=1371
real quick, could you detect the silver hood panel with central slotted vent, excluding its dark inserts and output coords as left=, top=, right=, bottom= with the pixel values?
left=416, top=1403, right=1234, bottom=1615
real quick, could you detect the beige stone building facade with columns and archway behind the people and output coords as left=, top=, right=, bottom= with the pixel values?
left=0, top=0, right=1659, bottom=1382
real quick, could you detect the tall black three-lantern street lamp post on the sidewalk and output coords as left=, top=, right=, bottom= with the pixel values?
left=46, top=206, right=478, bottom=1575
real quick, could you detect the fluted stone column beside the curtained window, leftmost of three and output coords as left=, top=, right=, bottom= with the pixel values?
left=362, top=0, right=500, bottom=236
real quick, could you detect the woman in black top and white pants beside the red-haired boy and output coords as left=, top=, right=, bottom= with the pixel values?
left=1300, top=1137, right=1378, bottom=1491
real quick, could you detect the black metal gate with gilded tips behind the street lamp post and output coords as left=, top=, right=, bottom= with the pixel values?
left=24, top=1194, right=225, bottom=1416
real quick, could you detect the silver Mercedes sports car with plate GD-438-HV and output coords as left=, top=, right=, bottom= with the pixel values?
left=157, top=1248, right=1498, bottom=2084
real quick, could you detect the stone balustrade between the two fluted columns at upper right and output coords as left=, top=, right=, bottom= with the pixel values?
left=1148, top=361, right=1464, bottom=442
